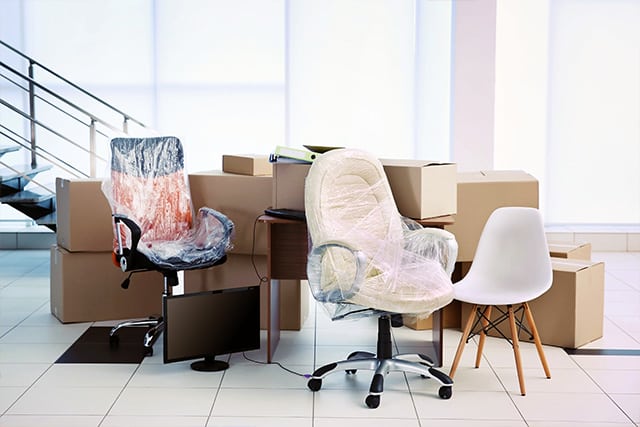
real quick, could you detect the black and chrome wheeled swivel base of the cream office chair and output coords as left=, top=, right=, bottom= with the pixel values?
left=307, top=316, right=453, bottom=408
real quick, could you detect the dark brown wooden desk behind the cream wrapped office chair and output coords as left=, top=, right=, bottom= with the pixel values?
left=258, top=215, right=454, bottom=367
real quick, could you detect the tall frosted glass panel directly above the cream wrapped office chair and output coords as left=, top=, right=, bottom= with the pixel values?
left=288, top=0, right=415, bottom=157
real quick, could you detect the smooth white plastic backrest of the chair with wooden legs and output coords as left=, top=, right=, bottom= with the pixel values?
left=467, top=206, right=553, bottom=295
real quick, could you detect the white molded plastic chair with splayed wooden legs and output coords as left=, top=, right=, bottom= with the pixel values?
left=449, top=207, right=552, bottom=396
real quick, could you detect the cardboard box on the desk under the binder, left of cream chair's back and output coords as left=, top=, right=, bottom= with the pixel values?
left=272, top=159, right=311, bottom=211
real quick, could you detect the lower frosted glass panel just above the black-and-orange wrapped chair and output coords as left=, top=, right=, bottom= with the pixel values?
left=158, top=86, right=284, bottom=172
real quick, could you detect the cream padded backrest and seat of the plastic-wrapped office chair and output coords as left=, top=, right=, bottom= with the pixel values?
left=305, top=149, right=453, bottom=320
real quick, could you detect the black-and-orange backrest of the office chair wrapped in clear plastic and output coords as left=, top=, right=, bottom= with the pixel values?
left=103, top=137, right=193, bottom=251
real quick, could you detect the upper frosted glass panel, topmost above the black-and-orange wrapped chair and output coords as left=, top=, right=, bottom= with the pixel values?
left=156, top=0, right=284, bottom=84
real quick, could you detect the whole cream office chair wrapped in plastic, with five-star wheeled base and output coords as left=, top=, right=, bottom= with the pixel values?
left=305, top=149, right=457, bottom=408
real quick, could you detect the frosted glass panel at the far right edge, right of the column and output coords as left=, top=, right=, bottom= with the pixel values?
left=546, top=0, right=640, bottom=223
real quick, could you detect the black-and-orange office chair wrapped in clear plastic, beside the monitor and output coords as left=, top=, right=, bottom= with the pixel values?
left=102, top=137, right=233, bottom=355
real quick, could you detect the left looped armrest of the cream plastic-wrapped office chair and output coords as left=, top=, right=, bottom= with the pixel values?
left=307, top=241, right=367, bottom=303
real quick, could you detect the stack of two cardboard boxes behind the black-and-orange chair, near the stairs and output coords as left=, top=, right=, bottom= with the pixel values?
left=50, top=178, right=163, bottom=323
